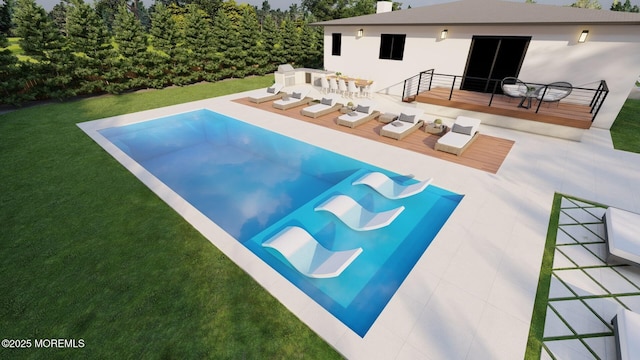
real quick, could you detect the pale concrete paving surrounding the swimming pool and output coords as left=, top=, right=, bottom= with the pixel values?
left=79, top=88, right=640, bottom=360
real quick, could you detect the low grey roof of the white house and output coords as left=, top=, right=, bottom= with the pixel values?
left=312, top=0, right=640, bottom=26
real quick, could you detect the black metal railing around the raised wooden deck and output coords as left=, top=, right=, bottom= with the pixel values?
left=402, top=69, right=609, bottom=122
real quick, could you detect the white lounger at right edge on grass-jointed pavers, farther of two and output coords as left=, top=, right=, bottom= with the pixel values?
left=602, top=207, right=640, bottom=266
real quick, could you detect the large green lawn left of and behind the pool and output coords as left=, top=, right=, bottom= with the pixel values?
left=0, top=76, right=340, bottom=359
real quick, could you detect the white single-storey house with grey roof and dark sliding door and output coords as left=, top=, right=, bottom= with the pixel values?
left=314, top=0, right=640, bottom=129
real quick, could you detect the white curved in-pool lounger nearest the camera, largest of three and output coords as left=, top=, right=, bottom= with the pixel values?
left=262, top=226, right=362, bottom=278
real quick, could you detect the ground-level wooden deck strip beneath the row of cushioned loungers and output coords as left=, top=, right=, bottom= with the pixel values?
left=235, top=98, right=514, bottom=174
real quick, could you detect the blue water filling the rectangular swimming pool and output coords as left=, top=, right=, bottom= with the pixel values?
left=100, top=110, right=462, bottom=336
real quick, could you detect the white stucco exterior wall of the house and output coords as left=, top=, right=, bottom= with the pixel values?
left=324, top=25, right=640, bottom=129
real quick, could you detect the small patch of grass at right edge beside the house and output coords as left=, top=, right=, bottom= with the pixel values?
left=611, top=99, right=640, bottom=153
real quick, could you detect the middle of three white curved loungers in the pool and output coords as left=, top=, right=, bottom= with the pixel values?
left=315, top=195, right=404, bottom=231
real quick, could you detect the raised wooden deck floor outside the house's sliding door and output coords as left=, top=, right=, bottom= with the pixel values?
left=415, top=87, right=593, bottom=129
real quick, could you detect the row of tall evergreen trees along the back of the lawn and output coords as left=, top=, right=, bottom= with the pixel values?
left=0, top=0, right=323, bottom=104
